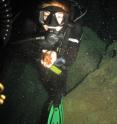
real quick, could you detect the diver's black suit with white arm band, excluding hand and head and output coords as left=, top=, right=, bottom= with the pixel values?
left=39, top=24, right=82, bottom=105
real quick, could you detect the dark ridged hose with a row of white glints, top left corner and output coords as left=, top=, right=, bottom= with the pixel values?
left=0, top=0, right=12, bottom=47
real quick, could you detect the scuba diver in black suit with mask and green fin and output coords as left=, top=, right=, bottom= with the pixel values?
left=37, top=0, right=85, bottom=124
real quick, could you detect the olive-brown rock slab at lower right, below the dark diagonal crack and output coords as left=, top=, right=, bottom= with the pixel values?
left=64, top=34, right=117, bottom=124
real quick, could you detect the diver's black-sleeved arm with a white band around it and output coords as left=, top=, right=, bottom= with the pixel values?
left=64, top=24, right=83, bottom=66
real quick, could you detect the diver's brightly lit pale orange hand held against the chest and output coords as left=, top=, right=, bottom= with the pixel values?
left=41, top=50, right=57, bottom=68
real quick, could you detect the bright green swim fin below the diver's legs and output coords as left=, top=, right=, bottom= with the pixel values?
left=47, top=100, right=63, bottom=124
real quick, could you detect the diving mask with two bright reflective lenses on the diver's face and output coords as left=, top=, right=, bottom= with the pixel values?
left=39, top=10, right=66, bottom=31
